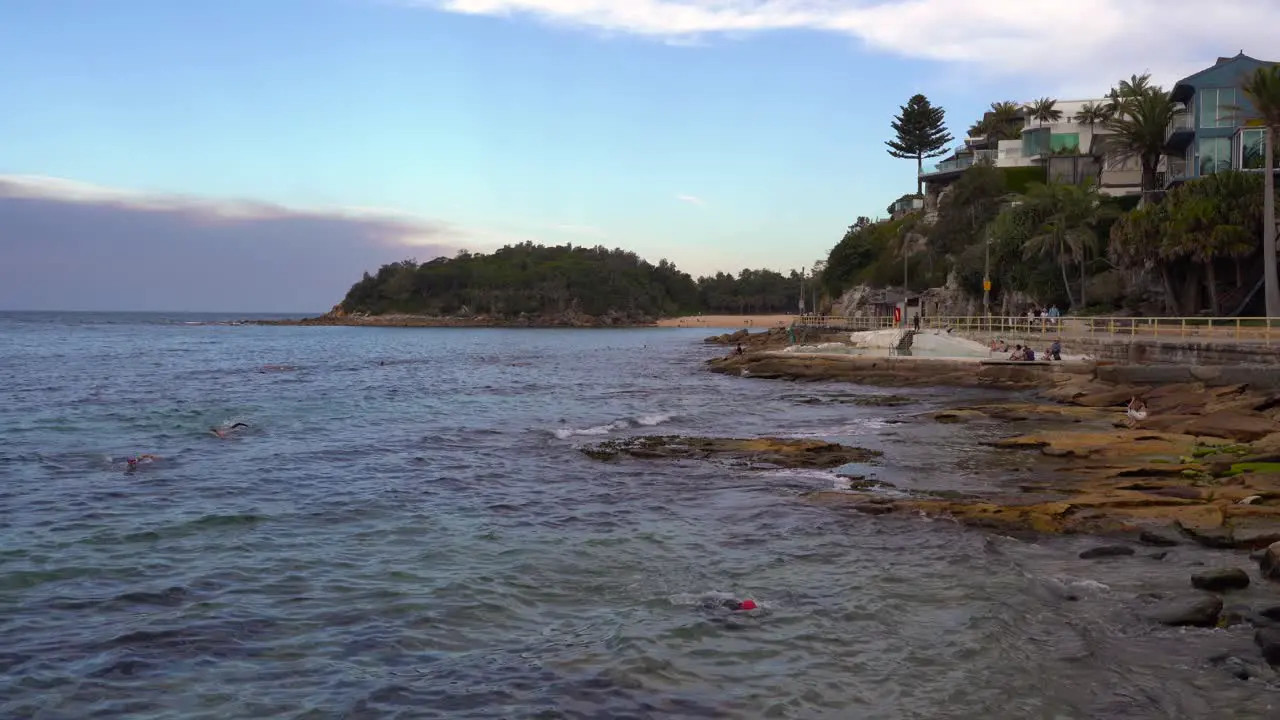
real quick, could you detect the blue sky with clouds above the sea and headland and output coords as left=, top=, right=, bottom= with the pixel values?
left=0, top=0, right=1280, bottom=313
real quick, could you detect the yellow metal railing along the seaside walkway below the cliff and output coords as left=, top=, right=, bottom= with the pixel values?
left=792, top=315, right=1280, bottom=345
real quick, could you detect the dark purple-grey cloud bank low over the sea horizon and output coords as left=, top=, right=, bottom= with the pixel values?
left=0, top=176, right=479, bottom=313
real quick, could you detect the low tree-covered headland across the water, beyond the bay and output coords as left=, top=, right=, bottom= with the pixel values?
left=342, top=242, right=800, bottom=320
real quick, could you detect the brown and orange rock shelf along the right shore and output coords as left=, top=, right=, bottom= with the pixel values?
left=708, top=333, right=1280, bottom=665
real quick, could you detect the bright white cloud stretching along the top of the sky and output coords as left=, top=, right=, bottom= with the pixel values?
left=406, top=0, right=1280, bottom=92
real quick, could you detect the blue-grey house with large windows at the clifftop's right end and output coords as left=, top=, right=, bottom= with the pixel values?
left=1162, top=53, right=1276, bottom=188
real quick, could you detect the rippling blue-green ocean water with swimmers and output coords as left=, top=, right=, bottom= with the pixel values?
left=0, top=313, right=1280, bottom=720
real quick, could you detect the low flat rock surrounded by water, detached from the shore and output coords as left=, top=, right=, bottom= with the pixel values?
left=581, top=436, right=881, bottom=469
